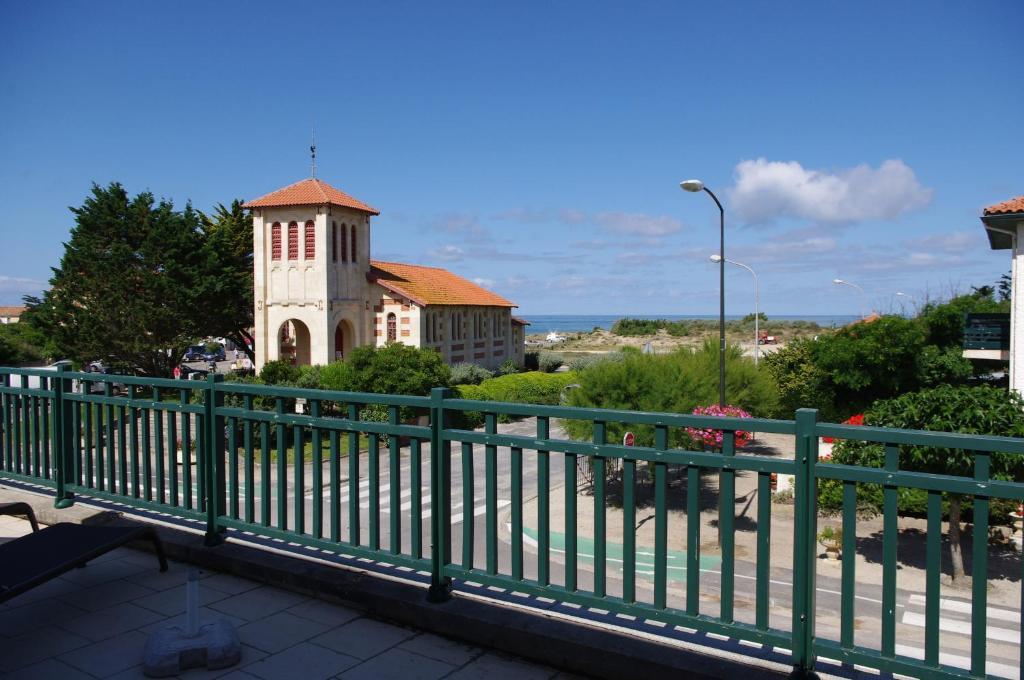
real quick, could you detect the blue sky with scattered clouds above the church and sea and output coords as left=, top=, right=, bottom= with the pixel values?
left=0, top=0, right=1024, bottom=316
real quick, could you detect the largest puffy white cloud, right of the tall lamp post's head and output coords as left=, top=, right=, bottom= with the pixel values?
left=731, top=158, right=932, bottom=222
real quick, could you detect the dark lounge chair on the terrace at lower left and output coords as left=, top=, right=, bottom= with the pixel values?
left=0, top=503, right=167, bottom=602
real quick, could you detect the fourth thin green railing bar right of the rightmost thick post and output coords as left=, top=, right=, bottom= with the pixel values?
left=971, top=451, right=987, bottom=677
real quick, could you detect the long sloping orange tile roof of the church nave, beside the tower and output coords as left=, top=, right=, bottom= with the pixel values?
left=369, top=260, right=516, bottom=307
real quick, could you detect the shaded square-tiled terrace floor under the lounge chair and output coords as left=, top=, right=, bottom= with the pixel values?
left=0, top=516, right=585, bottom=680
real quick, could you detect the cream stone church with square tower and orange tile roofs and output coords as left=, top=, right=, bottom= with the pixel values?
left=245, top=179, right=525, bottom=371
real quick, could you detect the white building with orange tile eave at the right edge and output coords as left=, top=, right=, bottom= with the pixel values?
left=965, top=196, right=1024, bottom=394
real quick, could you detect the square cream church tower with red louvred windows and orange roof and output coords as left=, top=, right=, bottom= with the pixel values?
left=245, top=179, right=380, bottom=371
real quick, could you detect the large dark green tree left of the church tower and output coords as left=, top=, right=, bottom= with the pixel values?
left=29, top=182, right=252, bottom=376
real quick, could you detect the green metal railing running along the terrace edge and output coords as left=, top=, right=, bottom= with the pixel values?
left=0, top=367, right=1024, bottom=678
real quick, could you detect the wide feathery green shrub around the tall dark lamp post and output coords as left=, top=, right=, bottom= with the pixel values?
left=564, top=342, right=777, bottom=447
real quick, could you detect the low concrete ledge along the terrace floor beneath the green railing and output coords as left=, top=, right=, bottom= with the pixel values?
left=0, top=486, right=788, bottom=680
